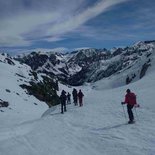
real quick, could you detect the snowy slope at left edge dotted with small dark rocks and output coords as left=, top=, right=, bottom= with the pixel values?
left=0, top=54, right=47, bottom=127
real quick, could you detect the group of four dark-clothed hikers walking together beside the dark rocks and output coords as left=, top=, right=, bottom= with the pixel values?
left=60, top=88, right=84, bottom=114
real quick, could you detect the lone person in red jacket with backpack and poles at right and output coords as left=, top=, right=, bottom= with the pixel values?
left=122, top=89, right=137, bottom=124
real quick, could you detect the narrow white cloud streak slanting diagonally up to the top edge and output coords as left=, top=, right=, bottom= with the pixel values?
left=48, top=0, right=127, bottom=34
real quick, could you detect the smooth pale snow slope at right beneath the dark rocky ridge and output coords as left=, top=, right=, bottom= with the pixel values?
left=92, top=44, right=155, bottom=90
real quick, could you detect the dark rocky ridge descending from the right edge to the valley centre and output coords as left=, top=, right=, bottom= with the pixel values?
left=69, top=41, right=155, bottom=85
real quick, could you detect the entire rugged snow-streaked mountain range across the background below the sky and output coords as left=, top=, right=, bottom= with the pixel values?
left=16, top=41, right=155, bottom=86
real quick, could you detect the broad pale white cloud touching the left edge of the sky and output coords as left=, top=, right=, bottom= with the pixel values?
left=0, top=12, right=59, bottom=46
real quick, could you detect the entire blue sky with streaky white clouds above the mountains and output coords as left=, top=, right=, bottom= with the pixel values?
left=0, top=0, right=155, bottom=51
